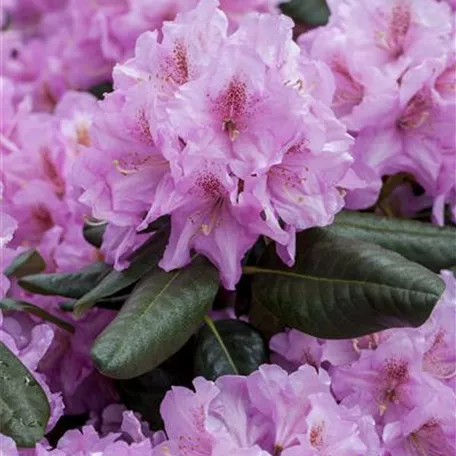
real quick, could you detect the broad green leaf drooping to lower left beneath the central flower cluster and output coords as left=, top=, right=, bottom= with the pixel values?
left=92, top=257, right=218, bottom=379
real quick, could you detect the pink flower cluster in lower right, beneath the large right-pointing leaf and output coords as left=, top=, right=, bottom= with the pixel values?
left=271, top=271, right=456, bottom=456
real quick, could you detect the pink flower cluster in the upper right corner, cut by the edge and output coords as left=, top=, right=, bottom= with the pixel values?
left=299, top=0, right=456, bottom=224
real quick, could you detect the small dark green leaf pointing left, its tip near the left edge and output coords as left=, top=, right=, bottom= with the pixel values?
left=18, top=263, right=112, bottom=299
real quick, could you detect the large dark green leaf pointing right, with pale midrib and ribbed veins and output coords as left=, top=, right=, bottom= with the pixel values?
left=248, top=229, right=444, bottom=339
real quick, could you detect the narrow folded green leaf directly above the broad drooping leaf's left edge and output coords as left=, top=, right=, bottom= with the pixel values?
left=74, top=228, right=169, bottom=318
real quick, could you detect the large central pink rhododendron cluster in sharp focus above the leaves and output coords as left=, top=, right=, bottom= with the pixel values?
left=74, top=0, right=358, bottom=289
